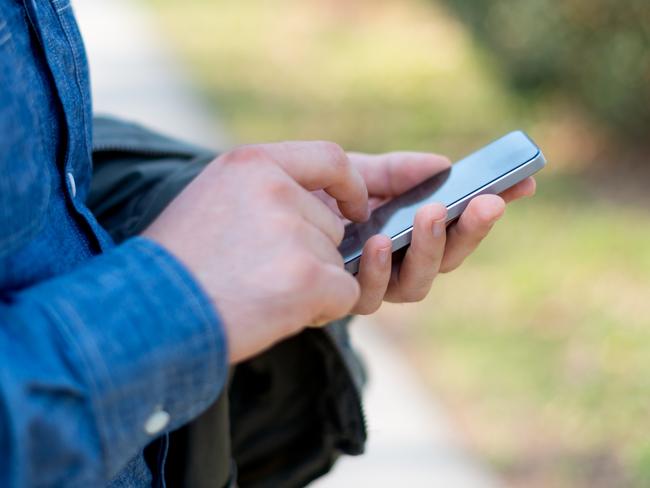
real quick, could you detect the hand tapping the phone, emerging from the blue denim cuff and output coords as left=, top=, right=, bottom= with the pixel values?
left=144, top=142, right=369, bottom=362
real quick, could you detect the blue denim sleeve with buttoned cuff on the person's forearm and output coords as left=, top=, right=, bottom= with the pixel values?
left=0, top=238, right=228, bottom=486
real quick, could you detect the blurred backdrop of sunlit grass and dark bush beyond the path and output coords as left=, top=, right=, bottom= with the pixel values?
left=142, top=0, right=650, bottom=487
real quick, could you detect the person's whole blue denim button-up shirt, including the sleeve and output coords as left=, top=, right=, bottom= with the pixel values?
left=0, top=0, right=227, bottom=487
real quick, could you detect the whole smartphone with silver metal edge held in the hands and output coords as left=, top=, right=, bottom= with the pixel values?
left=339, top=131, right=546, bottom=274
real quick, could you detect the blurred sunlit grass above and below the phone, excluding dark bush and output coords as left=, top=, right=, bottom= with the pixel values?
left=144, top=0, right=650, bottom=487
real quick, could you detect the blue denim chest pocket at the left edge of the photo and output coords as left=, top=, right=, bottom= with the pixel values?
left=0, top=11, right=51, bottom=257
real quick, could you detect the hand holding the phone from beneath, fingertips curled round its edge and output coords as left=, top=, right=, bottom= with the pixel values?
left=312, top=152, right=535, bottom=314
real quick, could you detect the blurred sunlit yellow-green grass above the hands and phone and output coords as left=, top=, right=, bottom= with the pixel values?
left=151, top=0, right=530, bottom=154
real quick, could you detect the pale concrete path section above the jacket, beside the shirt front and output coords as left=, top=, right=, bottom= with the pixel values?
left=72, top=0, right=225, bottom=149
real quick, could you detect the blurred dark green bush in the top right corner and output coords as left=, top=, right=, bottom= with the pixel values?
left=444, top=0, right=650, bottom=138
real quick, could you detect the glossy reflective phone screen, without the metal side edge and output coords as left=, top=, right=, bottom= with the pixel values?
left=339, top=132, right=539, bottom=262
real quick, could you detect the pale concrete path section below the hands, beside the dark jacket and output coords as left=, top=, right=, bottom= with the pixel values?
left=313, top=317, right=498, bottom=488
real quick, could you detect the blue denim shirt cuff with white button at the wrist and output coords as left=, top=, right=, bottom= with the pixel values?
left=38, top=237, right=228, bottom=476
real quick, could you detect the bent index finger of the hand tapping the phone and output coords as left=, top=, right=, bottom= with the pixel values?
left=262, top=141, right=370, bottom=222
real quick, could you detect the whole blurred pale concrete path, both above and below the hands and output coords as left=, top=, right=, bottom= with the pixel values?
left=73, top=0, right=497, bottom=488
